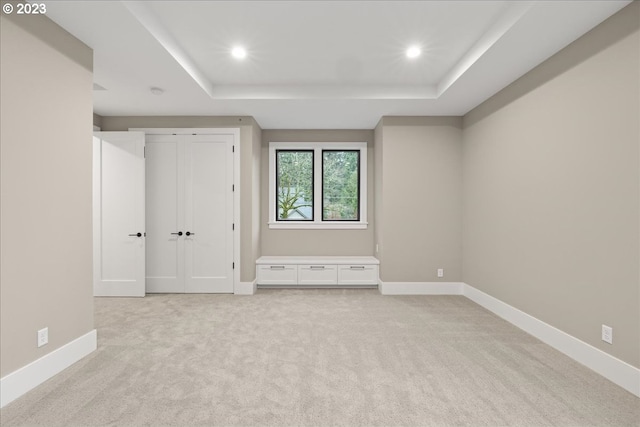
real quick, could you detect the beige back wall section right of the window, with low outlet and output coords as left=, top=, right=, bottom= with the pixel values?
left=375, top=117, right=462, bottom=282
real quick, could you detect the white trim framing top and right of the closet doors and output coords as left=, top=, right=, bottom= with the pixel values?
left=129, top=128, right=242, bottom=291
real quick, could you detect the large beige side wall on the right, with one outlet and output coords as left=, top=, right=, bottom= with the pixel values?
left=463, top=2, right=640, bottom=367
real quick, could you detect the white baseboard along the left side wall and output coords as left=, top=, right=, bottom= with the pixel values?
left=0, top=329, right=98, bottom=408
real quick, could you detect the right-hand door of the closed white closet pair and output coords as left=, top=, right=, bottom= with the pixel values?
left=185, top=135, right=233, bottom=293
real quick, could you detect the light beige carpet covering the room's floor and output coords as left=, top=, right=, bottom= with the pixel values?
left=0, top=289, right=640, bottom=426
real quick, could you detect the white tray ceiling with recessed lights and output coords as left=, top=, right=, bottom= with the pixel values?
left=47, top=0, right=630, bottom=129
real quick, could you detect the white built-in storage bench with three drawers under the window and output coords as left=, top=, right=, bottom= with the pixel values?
left=256, top=256, right=380, bottom=287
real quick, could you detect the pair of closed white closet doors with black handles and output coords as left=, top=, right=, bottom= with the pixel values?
left=146, top=134, right=234, bottom=293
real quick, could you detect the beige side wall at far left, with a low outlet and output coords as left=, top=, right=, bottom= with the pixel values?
left=0, top=10, right=94, bottom=377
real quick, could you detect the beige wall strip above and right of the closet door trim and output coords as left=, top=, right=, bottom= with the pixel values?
left=102, top=116, right=261, bottom=282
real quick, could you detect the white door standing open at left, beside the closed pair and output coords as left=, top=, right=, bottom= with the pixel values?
left=93, top=132, right=145, bottom=296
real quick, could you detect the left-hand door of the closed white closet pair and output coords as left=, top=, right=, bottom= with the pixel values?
left=146, top=135, right=185, bottom=293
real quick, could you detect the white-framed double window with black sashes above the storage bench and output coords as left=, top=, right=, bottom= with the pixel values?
left=269, top=142, right=367, bottom=228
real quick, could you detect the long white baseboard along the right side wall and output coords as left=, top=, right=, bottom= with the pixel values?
left=463, top=283, right=640, bottom=397
